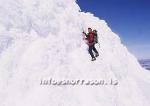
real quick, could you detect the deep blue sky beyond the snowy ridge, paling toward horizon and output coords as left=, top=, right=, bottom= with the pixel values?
left=77, top=0, right=150, bottom=59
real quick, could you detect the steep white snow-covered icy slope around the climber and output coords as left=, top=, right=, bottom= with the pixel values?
left=0, top=0, right=150, bottom=106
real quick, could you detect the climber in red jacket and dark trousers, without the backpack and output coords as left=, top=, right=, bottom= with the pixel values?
left=83, top=28, right=99, bottom=61
